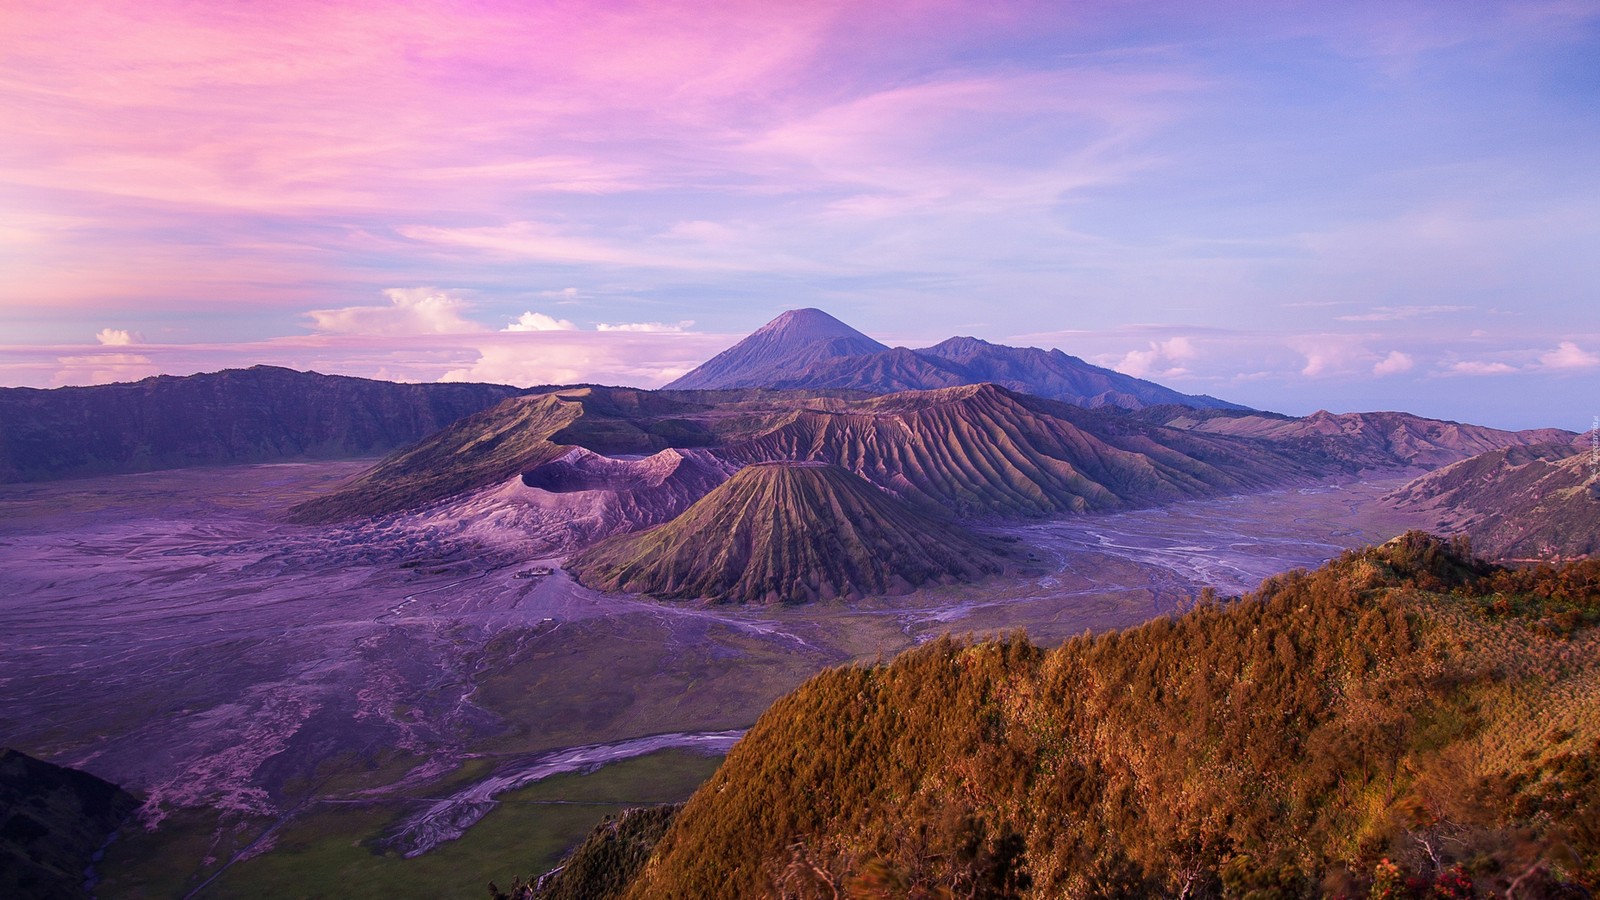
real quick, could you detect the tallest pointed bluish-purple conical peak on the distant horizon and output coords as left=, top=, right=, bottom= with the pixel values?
left=667, top=309, right=888, bottom=391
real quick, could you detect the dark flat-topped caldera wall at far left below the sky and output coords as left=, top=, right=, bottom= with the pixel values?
left=0, top=365, right=522, bottom=482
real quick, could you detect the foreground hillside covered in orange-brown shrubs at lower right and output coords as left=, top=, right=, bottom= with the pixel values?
left=518, top=533, right=1600, bottom=898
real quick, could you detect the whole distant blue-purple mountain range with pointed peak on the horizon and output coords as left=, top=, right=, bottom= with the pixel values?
left=667, top=309, right=1246, bottom=410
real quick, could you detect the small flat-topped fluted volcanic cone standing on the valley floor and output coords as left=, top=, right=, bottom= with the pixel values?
left=568, top=461, right=1002, bottom=604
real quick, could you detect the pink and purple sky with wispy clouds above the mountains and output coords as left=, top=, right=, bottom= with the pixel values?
left=0, top=0, right=1600, bottom=431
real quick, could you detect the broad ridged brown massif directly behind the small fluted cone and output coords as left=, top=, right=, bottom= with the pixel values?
left=296, top=384, right=1324, bottom=522
